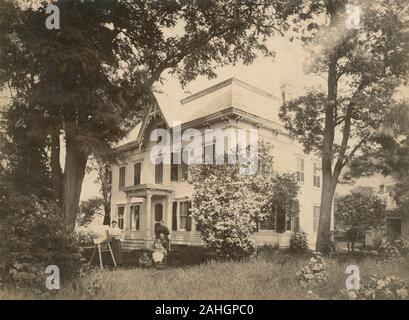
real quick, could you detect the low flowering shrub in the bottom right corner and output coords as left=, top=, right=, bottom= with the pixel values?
left=341, top=276, right=409, bottom=300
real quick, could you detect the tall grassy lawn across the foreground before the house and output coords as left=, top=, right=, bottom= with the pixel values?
left=0, top=252, right=409, bottom=300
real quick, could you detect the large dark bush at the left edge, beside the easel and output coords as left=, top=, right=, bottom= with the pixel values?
left=0, top=193, right=81, bottom=291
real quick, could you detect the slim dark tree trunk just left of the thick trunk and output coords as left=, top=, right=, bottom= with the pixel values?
left=51, top=128, right=63, bottom=206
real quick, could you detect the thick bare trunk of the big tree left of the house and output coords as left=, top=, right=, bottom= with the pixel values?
left=62, top=130, right=89, bottom=232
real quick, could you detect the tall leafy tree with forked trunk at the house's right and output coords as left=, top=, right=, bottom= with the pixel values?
left=280, top=0, right=409, bottom=250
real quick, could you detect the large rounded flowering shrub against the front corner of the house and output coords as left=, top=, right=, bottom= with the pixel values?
left=189, top=143, right=298, bottom=259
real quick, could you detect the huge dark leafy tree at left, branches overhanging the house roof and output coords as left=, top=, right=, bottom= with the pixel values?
left=0, top=0, right=302, bottom=230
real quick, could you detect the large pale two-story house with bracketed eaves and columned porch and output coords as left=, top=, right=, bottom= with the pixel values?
left=111, top=78, right=326, bottom=250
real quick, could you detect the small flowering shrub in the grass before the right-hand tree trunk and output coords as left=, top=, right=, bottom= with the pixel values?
left=296, top=252, right=328, bottom=286
